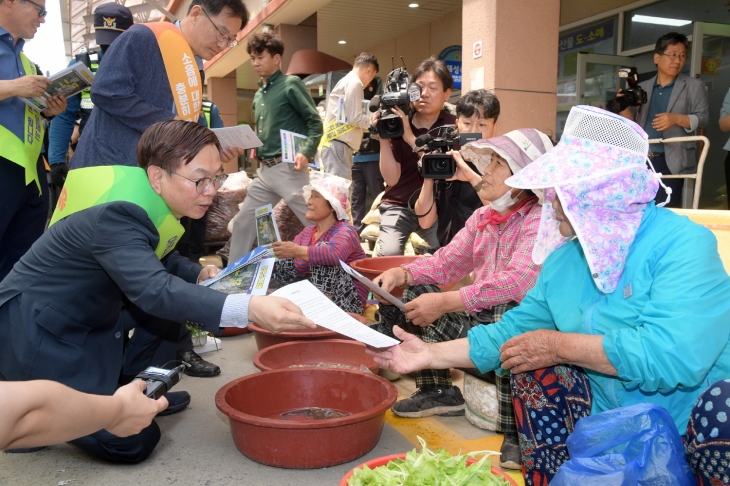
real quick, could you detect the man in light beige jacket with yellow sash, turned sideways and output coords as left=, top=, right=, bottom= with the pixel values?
left=320, top=52, right=380, bottom=180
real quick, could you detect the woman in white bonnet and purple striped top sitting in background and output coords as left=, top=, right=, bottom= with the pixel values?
left=273, top=175, right=367, bottom=314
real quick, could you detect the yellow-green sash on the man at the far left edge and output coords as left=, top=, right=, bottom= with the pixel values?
left=0, top=52, right=46, bottom=192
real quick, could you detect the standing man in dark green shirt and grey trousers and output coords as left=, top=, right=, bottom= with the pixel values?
left=229, top=33, right=322, bottom=261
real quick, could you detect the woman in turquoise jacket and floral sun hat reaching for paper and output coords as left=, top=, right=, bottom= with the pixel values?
left=371, top=106, right=730, bottom=485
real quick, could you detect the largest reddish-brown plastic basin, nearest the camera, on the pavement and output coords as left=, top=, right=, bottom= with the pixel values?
left=215, top=368, right=398, bottom=469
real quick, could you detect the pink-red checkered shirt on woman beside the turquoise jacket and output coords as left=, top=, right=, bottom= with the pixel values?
left=405, top=200, right=542, bottom=312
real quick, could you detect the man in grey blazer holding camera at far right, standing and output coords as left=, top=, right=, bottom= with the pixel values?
left=616, top=32, right=710, bottom=208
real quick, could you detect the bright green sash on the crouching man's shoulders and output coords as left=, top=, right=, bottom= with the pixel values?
left=49, top=165, right=185, bottom=264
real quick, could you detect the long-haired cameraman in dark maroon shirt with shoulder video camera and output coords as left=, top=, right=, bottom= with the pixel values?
left=373, top=57, right=456, bottom=256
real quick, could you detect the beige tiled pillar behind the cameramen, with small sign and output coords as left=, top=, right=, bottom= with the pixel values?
left=462, top=0, right=560, bottom=137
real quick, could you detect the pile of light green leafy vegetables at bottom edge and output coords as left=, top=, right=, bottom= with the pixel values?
left=347, top=437, right=510, bottom=486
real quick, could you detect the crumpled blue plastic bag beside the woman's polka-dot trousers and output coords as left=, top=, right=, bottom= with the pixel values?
left=550, top=403, right=697, bottom=486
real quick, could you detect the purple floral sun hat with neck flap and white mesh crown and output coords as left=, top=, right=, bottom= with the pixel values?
left=506, top=106, right=671, bottom=293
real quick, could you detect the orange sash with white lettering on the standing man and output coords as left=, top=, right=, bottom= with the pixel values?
left=141, top=22, right=203, bottom=122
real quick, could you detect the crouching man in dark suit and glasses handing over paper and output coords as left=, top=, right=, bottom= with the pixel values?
left=0, top=120, right=315, bottom=463
